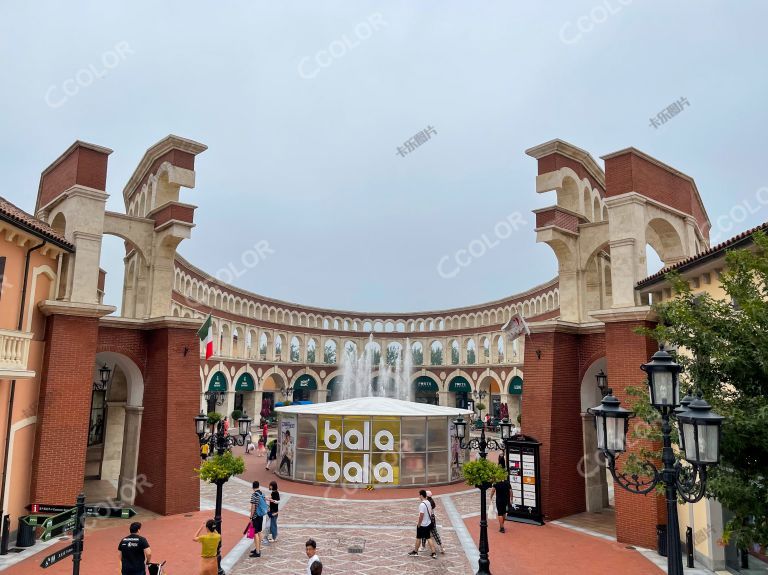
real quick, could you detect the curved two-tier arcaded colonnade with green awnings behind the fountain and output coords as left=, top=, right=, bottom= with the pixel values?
left=172, top=256, right=560, bottom=419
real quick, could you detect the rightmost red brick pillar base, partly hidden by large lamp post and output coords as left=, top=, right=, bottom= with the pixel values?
left=605, top=321, right=667, bottom=549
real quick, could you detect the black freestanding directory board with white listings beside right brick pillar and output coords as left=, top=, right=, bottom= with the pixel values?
left=506, top=435, right=544, bottom=525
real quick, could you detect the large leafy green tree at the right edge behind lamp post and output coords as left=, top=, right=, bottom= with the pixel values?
left=646, top=233, right=768, bottom=549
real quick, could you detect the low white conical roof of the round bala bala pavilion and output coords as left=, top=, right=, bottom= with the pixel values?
left=275, top=397, right=472, bottom=417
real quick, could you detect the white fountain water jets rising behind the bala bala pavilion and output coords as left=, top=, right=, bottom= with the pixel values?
left=341, top=334, right=413, bottom=401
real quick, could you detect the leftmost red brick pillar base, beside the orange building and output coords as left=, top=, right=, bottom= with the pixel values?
left=30, top=315, right=98, bottom=505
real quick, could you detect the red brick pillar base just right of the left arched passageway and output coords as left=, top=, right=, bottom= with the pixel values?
left=136, top=328, right=200, bottom=515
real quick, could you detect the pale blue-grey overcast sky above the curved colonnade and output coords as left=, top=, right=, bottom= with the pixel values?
left=0, top=0, right=768, bottom=312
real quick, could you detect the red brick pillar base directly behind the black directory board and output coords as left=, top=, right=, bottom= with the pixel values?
left=522, top=333, right=586, bottom=520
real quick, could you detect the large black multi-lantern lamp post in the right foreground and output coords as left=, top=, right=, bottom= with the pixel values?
left=589, top=347, right=725, bottom=575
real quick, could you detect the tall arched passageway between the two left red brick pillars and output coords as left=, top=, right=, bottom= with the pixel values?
left=85, top=352, right=144, bottom=505
